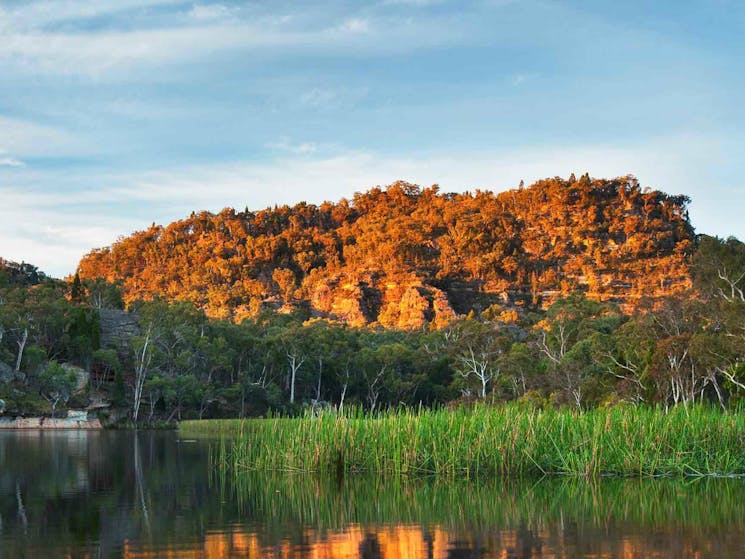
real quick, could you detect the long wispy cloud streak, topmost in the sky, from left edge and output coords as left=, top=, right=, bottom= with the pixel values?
left=0, top=2, right=474, bottom=78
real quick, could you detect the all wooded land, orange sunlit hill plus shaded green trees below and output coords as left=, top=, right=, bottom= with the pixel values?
left=0, top=177, right=745, bottom=422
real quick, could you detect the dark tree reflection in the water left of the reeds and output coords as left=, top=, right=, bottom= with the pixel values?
left=0, top=431, right=222, bottom=557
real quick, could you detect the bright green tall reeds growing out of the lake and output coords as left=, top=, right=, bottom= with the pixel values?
left=181, top=405, right=745, bottom=478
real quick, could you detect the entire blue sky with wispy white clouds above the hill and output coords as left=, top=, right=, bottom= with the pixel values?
left=0, top=0, right=745, bottom=277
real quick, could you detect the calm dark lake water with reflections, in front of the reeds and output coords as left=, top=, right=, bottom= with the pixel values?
left=0, top=431, right=745, bottom=559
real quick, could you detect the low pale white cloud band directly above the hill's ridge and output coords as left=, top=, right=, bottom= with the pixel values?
left=0, top=136, right=732, bottom=275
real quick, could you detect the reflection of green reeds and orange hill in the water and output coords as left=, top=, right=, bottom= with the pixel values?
left=226, top=474, right=745, bottom=559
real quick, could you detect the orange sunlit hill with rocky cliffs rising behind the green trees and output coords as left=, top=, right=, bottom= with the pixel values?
left=79, top=175, right=694, bottom=330
